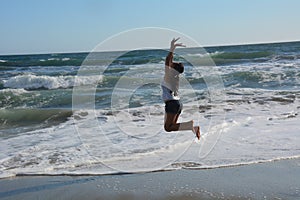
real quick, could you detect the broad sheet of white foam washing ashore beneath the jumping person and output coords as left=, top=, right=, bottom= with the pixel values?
left=0, top=95, right=300, bottom=177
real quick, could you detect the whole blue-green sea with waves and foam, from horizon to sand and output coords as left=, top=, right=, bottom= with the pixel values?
left=0, top=42, right=300, bottom=178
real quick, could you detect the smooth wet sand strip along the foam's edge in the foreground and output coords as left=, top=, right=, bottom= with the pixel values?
left=0, top=159, right=300, bottom=199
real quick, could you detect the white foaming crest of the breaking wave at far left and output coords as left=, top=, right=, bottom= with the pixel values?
left=3, top=74, right=102, bottom=89
